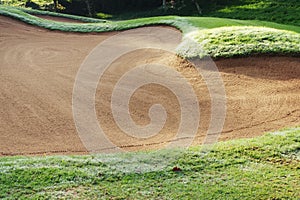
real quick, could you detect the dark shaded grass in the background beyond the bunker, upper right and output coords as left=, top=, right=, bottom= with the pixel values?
left=99, top=0, right=300, bottom=26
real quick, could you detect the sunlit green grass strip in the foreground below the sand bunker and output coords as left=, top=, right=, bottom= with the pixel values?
left=0, top=128, right=300, bottom=199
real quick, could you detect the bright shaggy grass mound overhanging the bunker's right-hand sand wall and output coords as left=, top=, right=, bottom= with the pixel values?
left=177, top=26, right=300, bottom=58
